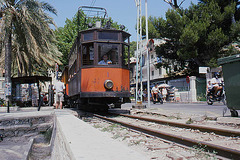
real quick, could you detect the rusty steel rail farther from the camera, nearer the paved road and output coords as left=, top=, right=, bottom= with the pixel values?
left=117, top=114, right=240, bottom=137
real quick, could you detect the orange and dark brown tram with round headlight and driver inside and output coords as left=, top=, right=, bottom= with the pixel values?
left=65, top=19, right=130, bottom=109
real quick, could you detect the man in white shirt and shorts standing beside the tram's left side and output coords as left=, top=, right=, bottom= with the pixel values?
left=53, top=80, right=65, bottom=109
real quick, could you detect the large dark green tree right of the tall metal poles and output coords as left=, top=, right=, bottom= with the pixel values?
left=145, top=0, right=240, bottom=74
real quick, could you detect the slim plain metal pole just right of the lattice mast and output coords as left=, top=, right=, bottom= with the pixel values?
left=145, top=0, right=150, bottom=107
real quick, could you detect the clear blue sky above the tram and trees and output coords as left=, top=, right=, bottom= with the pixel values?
left=45, top=0, right=198, bottom=41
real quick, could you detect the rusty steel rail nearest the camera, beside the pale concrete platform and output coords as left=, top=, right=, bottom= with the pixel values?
left=93, top=114, right=240, bottom=159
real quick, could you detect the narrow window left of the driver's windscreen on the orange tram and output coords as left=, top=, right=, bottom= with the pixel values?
left=82, top=43, right=94, bottom=65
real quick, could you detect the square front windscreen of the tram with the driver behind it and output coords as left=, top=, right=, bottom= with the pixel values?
left=98, top=44, right=119, bottom=65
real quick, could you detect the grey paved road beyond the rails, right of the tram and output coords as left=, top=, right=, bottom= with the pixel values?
left=122, top=102, right=234, bottom=117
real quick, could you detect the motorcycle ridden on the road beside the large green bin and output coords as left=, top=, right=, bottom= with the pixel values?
left=207, top=84, right=226, bottom=105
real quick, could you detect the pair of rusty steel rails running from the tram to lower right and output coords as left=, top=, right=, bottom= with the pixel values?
left=94, top=114, right=240, bottom=159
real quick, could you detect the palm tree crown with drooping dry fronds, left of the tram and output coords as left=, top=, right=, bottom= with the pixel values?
left=0, top=0, right=61, bottom=83
